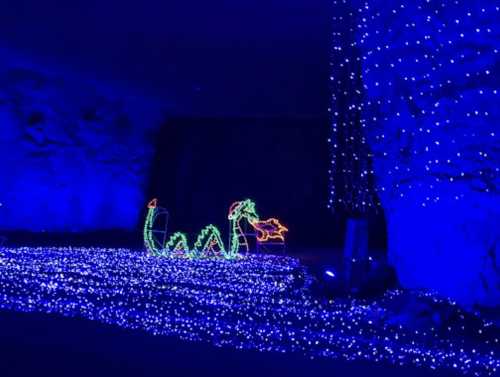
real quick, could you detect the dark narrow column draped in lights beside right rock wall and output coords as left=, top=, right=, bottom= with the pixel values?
left=328, top=0, right=379, bottom=284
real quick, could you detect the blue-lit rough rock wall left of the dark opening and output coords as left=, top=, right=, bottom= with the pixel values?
left=0, top=50, right=159, bottom=232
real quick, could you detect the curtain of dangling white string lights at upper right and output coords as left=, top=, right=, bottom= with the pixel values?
left=329, top=0, right=500, bottom=211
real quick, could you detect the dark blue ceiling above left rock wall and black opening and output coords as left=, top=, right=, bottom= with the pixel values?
left=0, top=0, right=331, bottom=116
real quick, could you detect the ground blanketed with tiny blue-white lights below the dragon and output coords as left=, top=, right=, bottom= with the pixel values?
left=0, top=248, right=500, bottom=375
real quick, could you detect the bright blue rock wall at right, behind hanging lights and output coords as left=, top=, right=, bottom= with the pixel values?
left=355, top=0, right=500, bottom=305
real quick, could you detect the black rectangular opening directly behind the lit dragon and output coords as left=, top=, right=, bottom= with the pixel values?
left=149, top=117, right=342, bottom=248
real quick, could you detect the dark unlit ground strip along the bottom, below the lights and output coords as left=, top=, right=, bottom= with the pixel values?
left=0, top=311, right=457, bottom=377
